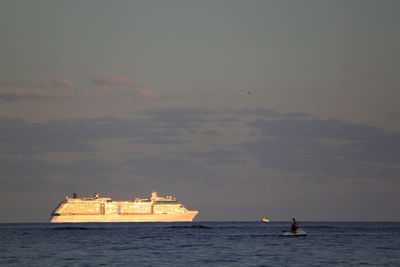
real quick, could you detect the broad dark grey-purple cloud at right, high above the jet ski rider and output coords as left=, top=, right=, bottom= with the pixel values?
left=241, top=119, right=400, bottom=179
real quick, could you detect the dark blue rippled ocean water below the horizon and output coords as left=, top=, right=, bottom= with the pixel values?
left=0, top=222, right=400, bottom=266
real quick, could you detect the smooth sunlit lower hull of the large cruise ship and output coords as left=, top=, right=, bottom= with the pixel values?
left=50, top=211, right=199, bottom=223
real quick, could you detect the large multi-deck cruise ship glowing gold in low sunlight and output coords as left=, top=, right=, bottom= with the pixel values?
left=50, top=192, right=199, bottom=223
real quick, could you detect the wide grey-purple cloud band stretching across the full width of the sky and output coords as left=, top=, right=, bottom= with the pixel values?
left=0, top=108, right=400, bottom=193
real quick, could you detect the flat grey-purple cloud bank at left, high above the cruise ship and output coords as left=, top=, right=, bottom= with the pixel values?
left=0, top=117, right=180, bottom=155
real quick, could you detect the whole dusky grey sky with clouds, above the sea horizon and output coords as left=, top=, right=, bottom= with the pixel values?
left=0, top=0, right=400, bottom=222
